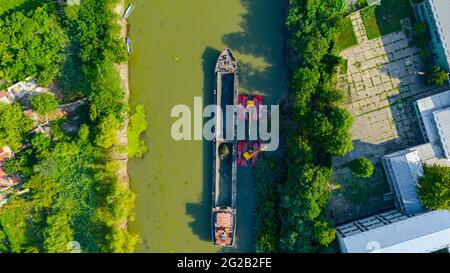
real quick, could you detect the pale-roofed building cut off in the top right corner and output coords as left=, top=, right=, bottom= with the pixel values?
left=417, top=0, right=450, bottom=72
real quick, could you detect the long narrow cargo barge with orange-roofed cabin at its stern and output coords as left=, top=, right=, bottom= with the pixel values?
left=211, top=48, right=239, bottom=247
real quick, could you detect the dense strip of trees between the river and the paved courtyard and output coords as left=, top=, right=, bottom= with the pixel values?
left=256, top=0, right=353, bottom=252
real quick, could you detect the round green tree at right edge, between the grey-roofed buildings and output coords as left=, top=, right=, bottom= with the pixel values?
left=418, top=165, right=450, bottom=210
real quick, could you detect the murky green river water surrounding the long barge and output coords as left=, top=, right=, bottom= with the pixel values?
left=129, top=0, right=285, bottom=252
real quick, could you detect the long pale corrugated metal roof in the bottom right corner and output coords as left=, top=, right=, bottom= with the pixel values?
left=339, top=210, right=450, bottom=253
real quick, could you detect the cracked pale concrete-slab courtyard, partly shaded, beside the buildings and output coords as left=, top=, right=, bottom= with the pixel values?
left=334, top=12, right=430, bottom=165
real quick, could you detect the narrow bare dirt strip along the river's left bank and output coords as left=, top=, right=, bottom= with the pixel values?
left=113, top=0, right=130, bottom=188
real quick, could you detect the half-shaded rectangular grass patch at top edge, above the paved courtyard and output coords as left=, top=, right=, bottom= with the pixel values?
left=361, top=0, right=414, bottom=39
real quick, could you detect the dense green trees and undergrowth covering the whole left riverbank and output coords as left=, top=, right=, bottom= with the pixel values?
left=0, top=0, right=138, bottom=252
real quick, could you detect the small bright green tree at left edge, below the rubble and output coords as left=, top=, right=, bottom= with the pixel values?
left=0, top=104, right=33, bottom=150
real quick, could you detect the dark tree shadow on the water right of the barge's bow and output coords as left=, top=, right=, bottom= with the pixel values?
left=222, top=0, right=286, bottom=102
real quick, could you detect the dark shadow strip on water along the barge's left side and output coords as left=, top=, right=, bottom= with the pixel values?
left=186, top=47, right=220, bottom=241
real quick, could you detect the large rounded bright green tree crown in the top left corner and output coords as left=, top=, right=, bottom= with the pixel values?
left=0, top=5, right=67, bottom=86
